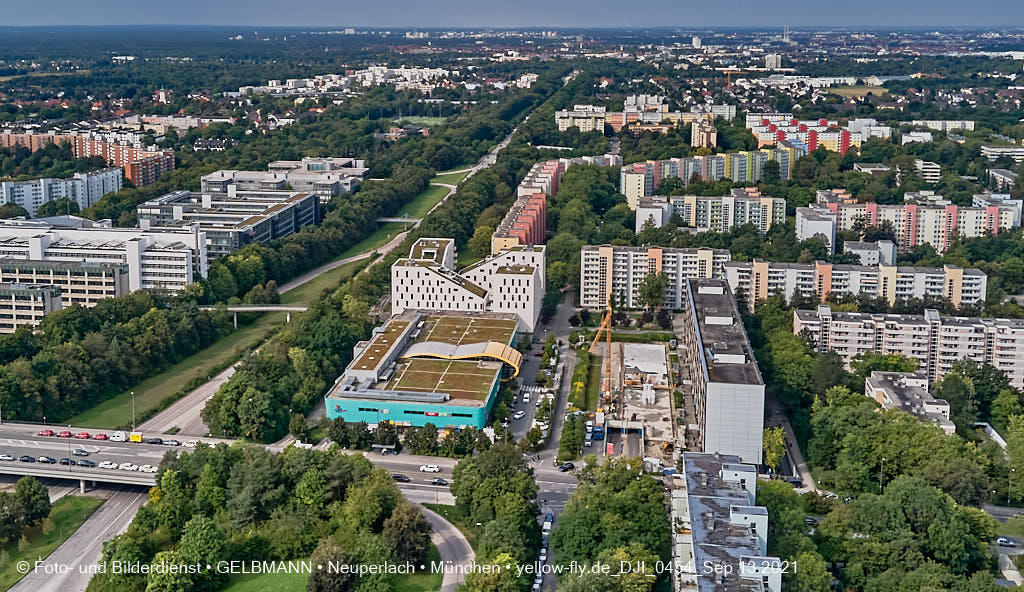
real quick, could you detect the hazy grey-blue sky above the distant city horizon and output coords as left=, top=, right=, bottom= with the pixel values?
left=6, top=0, right=1024, bottom=29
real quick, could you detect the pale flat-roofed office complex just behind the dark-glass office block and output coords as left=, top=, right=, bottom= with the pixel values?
left=200, top=157, right=370, bottom=202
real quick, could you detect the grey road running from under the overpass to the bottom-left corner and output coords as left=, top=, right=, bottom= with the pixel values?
left=9, top=485, right=148, bottom=592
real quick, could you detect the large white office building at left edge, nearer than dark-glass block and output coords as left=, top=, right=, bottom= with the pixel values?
left=0, top=220, right=207, bottom=292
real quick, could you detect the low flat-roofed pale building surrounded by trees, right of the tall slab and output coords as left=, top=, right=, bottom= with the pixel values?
left=864, top=371, right=956, bottom=434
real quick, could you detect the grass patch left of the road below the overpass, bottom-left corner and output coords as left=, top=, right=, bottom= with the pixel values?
left=0, top=496, right=103, bottom=590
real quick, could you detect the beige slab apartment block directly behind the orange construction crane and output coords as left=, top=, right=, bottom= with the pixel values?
left=580, top=245, right=731, bottom=310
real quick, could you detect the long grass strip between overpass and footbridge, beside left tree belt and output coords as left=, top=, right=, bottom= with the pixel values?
left=68, top=312, right=285, bottom=429
